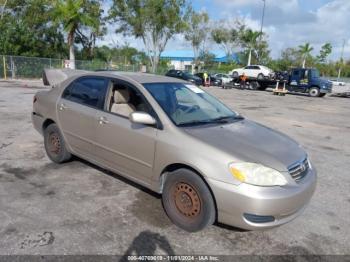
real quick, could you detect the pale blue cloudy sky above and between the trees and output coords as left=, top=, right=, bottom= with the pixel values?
left=101, top=0, right=350, bottom=60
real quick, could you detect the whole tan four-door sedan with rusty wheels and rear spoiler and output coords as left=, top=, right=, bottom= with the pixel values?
left=32, top=70, right=317, bottom=232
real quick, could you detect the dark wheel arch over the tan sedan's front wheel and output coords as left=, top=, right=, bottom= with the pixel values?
left=159, top=163, right=218, bottom=221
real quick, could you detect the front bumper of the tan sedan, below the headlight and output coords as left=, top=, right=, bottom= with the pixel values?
left=207, top=169, right=317, bottom=230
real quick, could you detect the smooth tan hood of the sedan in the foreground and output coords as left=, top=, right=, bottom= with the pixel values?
left=185, top=120, right=306, bottom=171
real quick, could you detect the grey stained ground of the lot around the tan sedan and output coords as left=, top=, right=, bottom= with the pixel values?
left=0, top=81, right=350, bottom=255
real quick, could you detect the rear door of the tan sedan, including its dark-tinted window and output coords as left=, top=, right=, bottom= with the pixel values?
left=57, top=76, right=107, bottom=157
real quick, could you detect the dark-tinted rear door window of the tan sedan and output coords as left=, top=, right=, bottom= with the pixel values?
left=62, top=77, right=107, bottom=109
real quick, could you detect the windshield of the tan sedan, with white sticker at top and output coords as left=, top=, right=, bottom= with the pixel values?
left=143, top=83, right=242, bottom=126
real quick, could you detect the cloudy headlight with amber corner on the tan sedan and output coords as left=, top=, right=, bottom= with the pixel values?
left=229, top=163, right=287, bottom=186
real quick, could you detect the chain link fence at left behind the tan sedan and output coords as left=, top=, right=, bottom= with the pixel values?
left=0, top=55, right=148, bottom=79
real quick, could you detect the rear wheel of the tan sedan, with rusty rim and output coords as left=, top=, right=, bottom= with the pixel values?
left=44, top=124, right=72, bottom=164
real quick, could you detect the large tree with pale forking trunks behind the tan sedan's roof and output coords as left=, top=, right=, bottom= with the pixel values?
left=109, top=0, right=187, bottom=73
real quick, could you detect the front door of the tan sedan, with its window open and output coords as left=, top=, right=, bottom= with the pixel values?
left=96, top=79, right=157, bottom=184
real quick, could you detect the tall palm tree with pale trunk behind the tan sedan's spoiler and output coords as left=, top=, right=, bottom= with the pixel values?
left=53, top=0, right=99, bottom=69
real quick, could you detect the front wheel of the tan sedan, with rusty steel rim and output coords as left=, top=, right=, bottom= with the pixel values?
left=162, top=168, right=216, bottom=232
